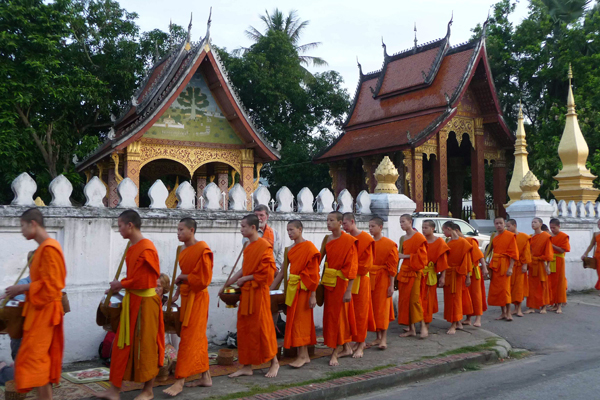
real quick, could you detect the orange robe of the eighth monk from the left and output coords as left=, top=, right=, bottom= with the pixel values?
left=370, top=237, right=399, bottom=331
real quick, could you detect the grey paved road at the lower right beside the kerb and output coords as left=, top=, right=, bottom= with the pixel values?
left=356, top=294, right=600, bottom=400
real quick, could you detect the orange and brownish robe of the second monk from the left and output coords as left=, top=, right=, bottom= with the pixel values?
left=110, top=239, right=165, bottom=388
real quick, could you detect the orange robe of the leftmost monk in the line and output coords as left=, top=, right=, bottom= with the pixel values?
left=15, top=238, right=67, bottom=393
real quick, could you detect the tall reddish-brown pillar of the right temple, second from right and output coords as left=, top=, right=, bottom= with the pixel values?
left=471, top=118, right=486, bottom=219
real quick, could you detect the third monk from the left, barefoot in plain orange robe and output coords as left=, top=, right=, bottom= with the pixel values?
left=163, top=217, right=213, bottom=396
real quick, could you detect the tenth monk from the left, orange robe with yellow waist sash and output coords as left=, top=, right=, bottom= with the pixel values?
left=421, top=219, right=450, bottom=325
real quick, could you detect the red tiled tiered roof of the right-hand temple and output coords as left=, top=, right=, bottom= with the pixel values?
left=315, top=21, right=514, bottom=163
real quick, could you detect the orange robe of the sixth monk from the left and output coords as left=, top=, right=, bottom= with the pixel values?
left=323, top=232, right=358, bottom=349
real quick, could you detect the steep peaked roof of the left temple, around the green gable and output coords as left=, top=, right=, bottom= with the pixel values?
left=77, top=25, right=280, bottom=171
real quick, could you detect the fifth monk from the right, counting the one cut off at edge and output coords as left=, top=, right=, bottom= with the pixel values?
left=488, top=217, right=519, bottom=321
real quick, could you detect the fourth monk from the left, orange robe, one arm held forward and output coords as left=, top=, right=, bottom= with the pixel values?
left=221, top=214, right=279, bottom=378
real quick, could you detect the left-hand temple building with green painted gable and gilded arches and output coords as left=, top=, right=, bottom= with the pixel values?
left=77, top=19, right=279, bottom=208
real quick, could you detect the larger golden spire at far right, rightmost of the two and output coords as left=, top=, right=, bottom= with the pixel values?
left=552, top=64, right=600, bottom=203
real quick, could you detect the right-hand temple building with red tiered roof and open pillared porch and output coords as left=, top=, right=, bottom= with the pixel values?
left=315, top=21, right=515, bottom=218
